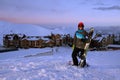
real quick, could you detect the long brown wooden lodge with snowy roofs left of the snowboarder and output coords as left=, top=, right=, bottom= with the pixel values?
left=3, top=34, right=72, bottom=48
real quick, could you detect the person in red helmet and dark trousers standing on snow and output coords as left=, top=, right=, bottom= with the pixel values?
left=72, top=22, right=89, bottom=67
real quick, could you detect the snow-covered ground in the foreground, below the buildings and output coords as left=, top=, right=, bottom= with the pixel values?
left=0, top=47, right=120, bottom=80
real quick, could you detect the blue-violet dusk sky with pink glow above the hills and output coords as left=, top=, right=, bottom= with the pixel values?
left=0, top=0, right=120, bottom=26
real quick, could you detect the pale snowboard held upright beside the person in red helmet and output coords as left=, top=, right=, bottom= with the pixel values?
left=79, top=28, right=94, bottom=67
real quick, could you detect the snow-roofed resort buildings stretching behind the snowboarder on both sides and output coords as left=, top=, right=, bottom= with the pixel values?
left=0, top=27, right=120, bottom=52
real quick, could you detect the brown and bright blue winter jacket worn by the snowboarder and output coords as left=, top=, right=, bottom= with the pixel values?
left=73, top=30, right=88, bottom=49
